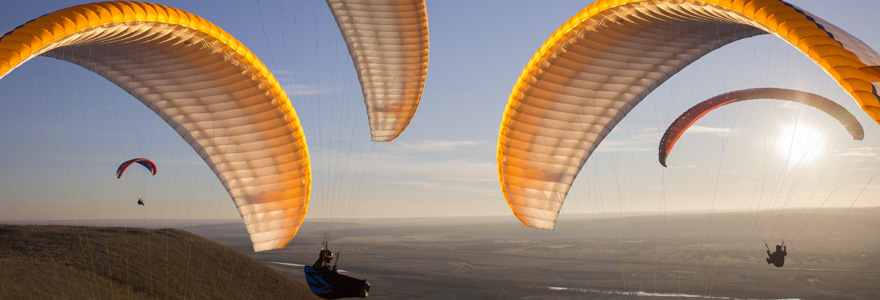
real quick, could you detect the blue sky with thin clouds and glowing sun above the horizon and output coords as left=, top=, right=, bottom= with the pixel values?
left=0, top=0, right=880, bottom=230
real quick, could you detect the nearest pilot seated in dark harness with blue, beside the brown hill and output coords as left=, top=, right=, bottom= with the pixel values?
left=304, top=241, right=370, bottom=299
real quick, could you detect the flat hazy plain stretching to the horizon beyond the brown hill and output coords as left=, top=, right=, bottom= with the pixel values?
left=191, top=208, right=880, bottom=299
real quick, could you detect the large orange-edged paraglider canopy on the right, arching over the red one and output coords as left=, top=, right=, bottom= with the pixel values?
left=497, top=0, right=880, bottom=229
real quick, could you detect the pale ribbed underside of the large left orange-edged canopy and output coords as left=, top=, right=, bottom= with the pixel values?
left=41, top=22, right=309, bottom=251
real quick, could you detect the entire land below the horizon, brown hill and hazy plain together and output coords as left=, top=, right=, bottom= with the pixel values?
left=0, top=208, right=880, bottom=299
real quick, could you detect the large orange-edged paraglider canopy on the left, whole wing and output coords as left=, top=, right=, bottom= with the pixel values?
left=0, top=2, right=311, bottom=251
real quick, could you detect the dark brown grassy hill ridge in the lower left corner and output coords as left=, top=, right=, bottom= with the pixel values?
left=0, top=225, right=318, bottom=299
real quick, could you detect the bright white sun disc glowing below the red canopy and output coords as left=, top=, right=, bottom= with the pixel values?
left=775, top=123, right=824, bottom=163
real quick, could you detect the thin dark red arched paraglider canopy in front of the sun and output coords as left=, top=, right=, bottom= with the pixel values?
left=659, top=88, right=865, bottom=167
